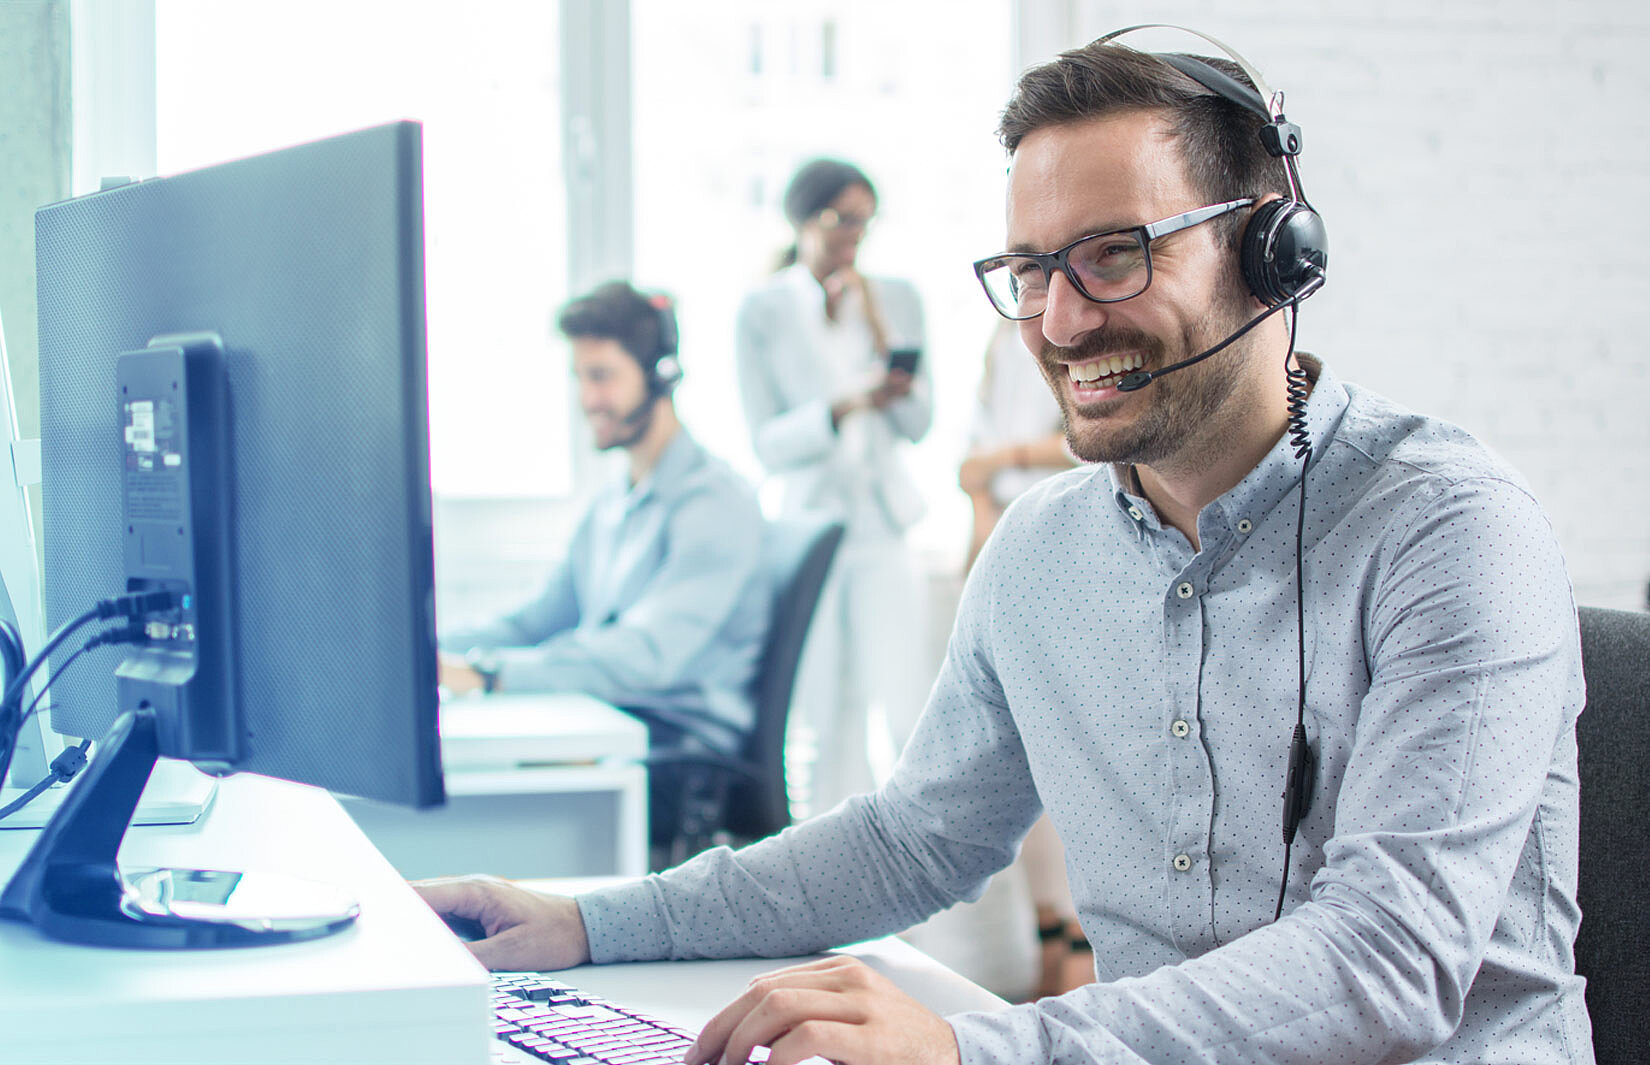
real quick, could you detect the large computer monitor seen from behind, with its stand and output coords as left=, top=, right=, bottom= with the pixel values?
left=0, top=122, right=444, bottom=946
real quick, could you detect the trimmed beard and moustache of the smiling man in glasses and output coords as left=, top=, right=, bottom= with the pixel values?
left=1038, top=302, right=1247, bottom=466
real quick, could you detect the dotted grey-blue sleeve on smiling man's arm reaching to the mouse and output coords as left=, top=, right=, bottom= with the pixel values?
left=579, top=541, right=1041, bottom=963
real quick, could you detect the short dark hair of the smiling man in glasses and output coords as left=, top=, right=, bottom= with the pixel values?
left=997, top=43, right=1289, bottom=246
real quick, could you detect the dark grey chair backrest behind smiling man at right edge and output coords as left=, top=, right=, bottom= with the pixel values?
left=1576, top=606, right=1650, bottom=1065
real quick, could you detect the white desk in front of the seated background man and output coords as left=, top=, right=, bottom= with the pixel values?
left=343, top=693, right=647, bottom=878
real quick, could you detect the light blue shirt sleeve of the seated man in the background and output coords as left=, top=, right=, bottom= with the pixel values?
left=498, top=485, right=764, bottom=705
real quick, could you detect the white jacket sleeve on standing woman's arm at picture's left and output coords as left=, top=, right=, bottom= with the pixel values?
left=734, top=292, right=837, bottom=474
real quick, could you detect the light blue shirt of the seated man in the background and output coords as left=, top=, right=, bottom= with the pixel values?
left=442, top=429, right=772, bottom=750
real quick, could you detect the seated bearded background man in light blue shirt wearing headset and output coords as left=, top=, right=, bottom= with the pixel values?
left=441, top=281, right=769, bottom=762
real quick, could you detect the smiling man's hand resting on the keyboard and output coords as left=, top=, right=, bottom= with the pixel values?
left=686, top=958, right=959, bottom=1065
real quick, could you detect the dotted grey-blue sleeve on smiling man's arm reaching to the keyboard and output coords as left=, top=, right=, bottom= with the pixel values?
left=950, top=480, right=1581, bottom=1065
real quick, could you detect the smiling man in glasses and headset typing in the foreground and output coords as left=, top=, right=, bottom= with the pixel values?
left=412, top=35, right=1592, bottom=1065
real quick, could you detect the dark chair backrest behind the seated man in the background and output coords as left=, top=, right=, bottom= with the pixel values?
left=724, top=517, right=843, bottom=839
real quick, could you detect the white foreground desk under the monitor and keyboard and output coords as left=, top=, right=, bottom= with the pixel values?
left=0, top=774, right=1003, bottom=1065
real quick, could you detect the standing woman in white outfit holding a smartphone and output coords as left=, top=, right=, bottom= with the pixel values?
left=738, top=159, right=934, bottom=812
